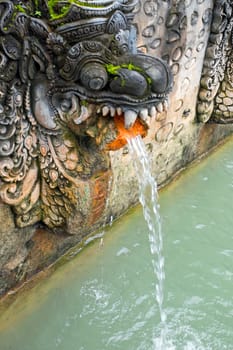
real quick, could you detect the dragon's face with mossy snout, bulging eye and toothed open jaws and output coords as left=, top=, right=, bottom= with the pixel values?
left=48, top=46, right=172, bottom=149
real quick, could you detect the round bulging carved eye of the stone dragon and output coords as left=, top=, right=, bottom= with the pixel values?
left=80, top=62, right=108, bottom=91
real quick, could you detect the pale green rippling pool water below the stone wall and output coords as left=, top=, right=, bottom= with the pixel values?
left=0, top=140, right=233, bottom=350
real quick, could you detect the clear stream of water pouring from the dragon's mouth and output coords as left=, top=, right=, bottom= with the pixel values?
left=128, top=136, right=167, bottom=350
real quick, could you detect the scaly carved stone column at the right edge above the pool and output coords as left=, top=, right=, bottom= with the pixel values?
left=197, top=0, right=233, bottom=123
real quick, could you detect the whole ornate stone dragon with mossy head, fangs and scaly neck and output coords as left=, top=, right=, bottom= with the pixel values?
left=0, top=0, right=172, bottom=228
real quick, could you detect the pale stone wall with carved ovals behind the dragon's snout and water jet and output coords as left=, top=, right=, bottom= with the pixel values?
left=108, top=0, right=223, bottom=219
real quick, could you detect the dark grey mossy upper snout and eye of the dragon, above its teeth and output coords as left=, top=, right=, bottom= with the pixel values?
left=59, top=41, right=172, bottom=105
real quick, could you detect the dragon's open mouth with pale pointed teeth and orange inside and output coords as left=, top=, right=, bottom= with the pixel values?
left=52, top=87, right=168, bottom=150
